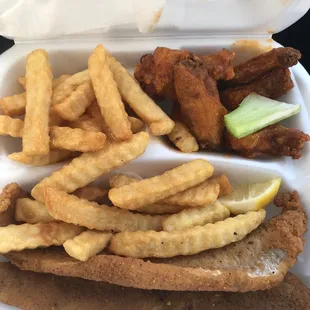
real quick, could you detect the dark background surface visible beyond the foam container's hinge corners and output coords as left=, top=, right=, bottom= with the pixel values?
left=0, top=11, right=310, bottom=73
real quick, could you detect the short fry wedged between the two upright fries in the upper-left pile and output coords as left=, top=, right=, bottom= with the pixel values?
left=53, top=82, right=95, bottom=121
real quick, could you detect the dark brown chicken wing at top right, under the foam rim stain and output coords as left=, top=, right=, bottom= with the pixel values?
left=226, top=47, right=301, bottom=87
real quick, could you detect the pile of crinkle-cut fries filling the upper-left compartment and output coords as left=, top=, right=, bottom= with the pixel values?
left=0, top=45, right=174, bottom=166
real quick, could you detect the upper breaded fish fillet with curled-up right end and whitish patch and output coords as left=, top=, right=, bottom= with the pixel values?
left=6, top=191, right=307, bottom=292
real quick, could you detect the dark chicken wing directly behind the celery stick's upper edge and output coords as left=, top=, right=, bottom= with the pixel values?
left=220, top=68, right=294, bottom=111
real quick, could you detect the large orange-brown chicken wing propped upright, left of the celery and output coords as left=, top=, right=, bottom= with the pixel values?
left=174, top=60, right=227, bottom=150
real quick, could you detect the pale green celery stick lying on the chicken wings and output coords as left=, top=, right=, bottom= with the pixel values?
left=224, top=93, right=300, bottom=138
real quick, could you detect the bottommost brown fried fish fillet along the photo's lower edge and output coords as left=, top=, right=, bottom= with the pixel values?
left=0, top=263, right=310, bottom=310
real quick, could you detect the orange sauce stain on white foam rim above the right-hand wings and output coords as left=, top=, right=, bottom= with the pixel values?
left=231, top=40, right=272, bottom=65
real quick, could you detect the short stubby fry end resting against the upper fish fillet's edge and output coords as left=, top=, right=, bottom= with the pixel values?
left=63, top=230, right=112, bottom=262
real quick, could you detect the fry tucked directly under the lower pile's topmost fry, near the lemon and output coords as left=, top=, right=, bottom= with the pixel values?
left=162, top=180, right=220, bottom=207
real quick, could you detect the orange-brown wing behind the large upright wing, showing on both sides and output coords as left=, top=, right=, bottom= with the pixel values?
left=134, top=47, right=235, bottom=100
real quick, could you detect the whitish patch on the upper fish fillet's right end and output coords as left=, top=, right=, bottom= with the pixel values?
left=248, top=249, right=286, bottom=278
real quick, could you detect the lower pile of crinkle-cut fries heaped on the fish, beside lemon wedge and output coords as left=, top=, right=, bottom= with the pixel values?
left=0, top=154, right=266, bottom=261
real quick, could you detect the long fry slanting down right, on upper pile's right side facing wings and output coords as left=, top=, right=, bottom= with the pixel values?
left=108, top=55, right=174, bottom=136
